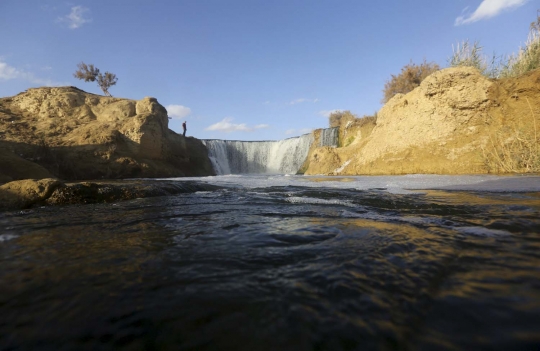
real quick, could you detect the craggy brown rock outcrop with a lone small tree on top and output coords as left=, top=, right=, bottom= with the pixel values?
left=0, top=87, right=213, bottom=184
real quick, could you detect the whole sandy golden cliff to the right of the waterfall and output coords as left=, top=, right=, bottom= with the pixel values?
left=304, top=67, right=540, bottom=175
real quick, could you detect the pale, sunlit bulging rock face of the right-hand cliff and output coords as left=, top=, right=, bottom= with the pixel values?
left=362, top=67, right=493, bottom=162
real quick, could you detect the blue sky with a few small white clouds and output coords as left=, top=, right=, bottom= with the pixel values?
left=0, top=0, right=540, bottom=140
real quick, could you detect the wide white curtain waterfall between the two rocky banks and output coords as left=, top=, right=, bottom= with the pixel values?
left=203, top=133, right=313, bottom=174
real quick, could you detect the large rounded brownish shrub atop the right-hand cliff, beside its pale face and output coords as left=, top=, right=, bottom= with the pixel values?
left=381, top=60, right=441, bottom=104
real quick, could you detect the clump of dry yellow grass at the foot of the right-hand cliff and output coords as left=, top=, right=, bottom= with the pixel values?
left=482, top=99, right=540, bottom=173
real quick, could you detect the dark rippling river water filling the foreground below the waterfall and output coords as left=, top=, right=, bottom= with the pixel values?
left=0, top=175, right=540, bottom=350
